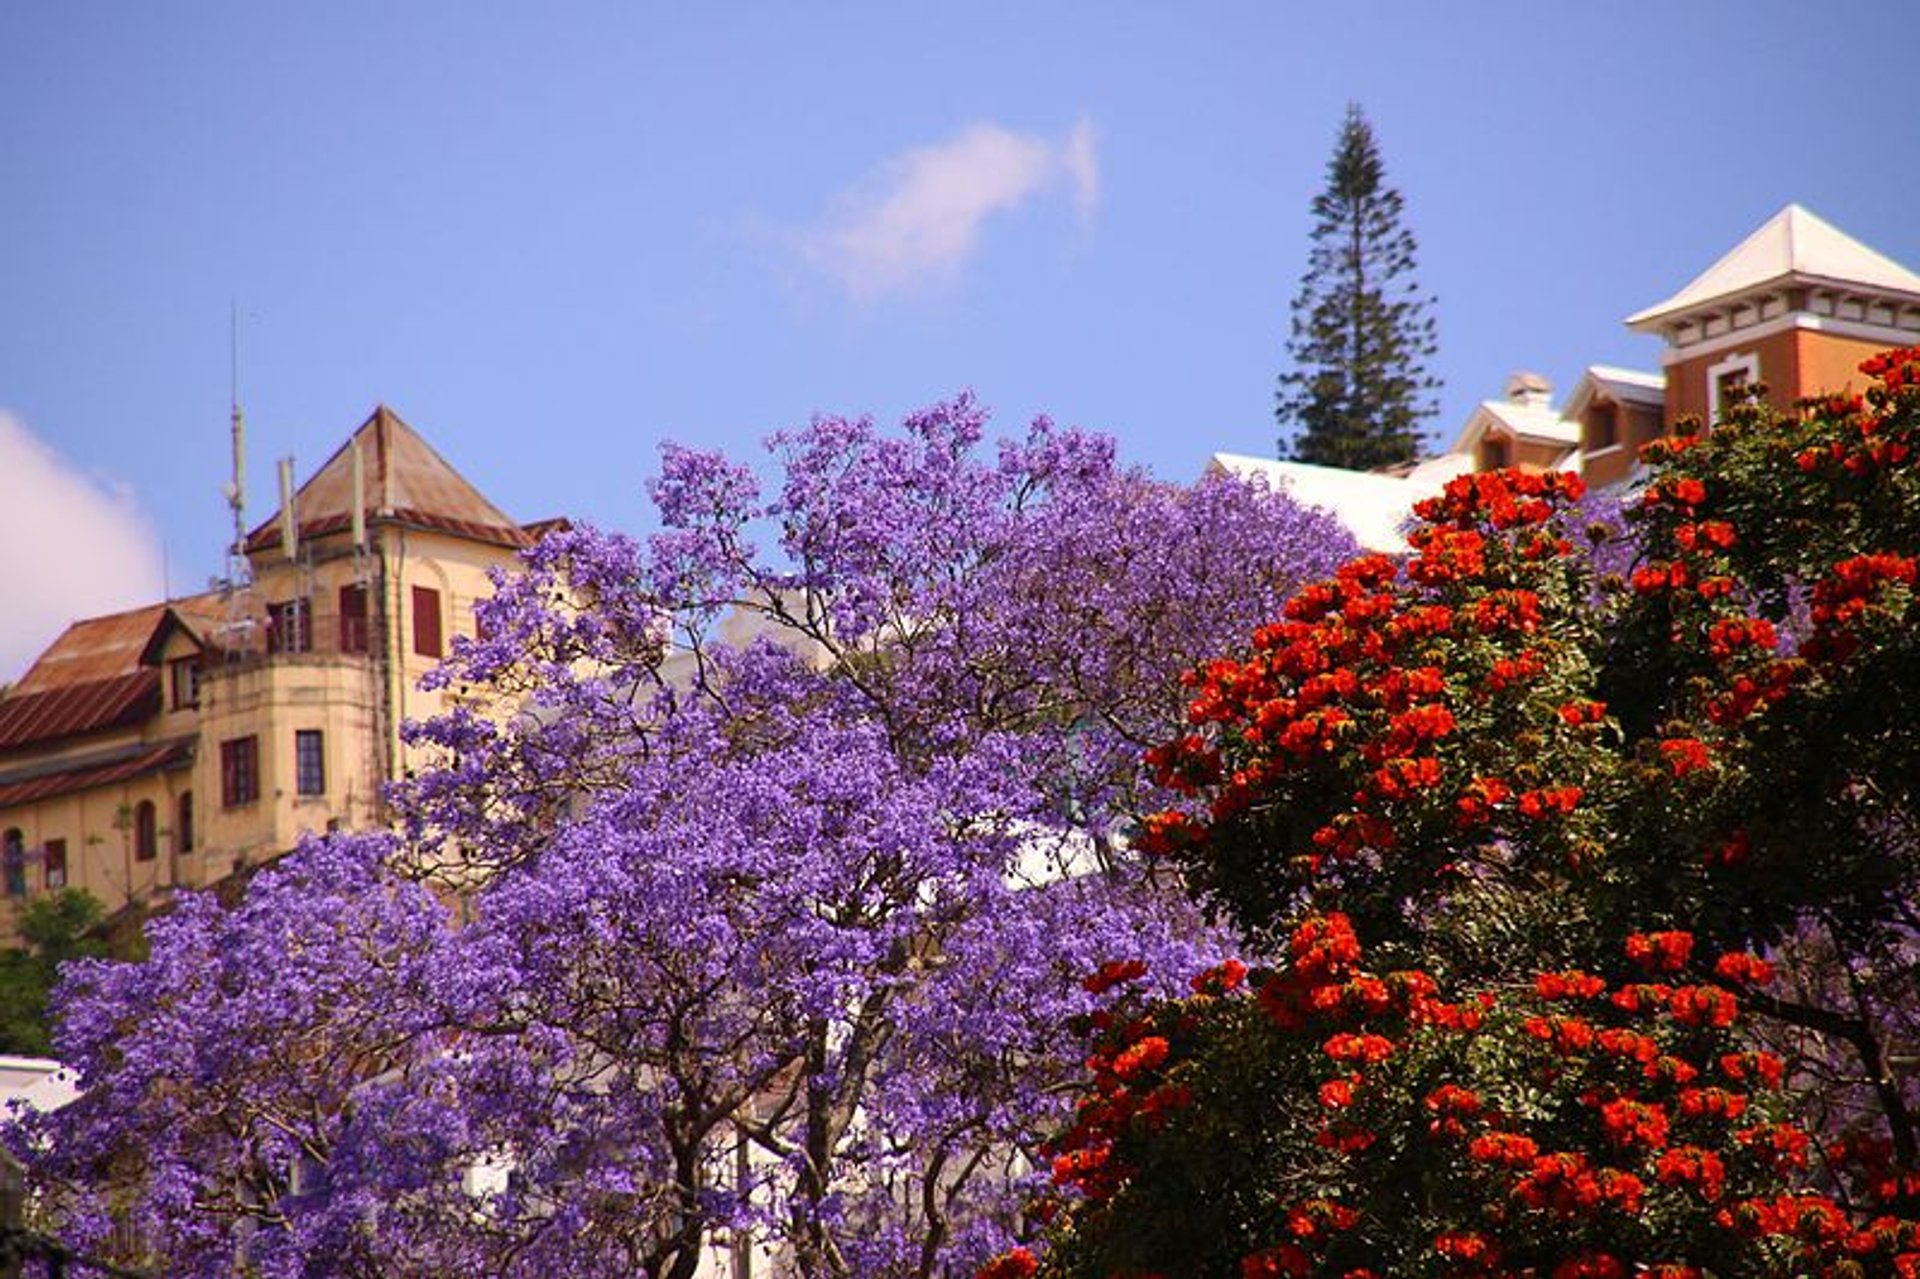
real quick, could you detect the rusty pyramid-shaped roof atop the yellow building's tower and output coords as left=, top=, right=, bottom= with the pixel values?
left=246, top=403, right=532, bottom=551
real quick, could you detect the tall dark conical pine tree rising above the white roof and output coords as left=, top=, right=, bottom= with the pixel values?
left=1275, top=104, right=1440, bottom=471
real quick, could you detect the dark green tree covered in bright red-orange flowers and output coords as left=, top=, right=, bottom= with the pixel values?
left=998, top=348, right=1920, bottom=1279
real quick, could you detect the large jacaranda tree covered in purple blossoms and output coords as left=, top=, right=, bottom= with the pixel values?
left=13, top=399, right=1352, bottom=1277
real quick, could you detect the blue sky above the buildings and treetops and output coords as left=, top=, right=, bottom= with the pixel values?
left=0, top=0, right=1920, bottom=680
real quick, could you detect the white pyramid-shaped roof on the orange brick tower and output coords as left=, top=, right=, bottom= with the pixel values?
left=1626, top=204, right=1920, bottom=330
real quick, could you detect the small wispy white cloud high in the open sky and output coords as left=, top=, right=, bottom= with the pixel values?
left=803, top=119, right=1100, bottom=300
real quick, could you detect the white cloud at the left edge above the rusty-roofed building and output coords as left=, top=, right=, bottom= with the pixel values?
left=0, top=411, right=165, bottom=682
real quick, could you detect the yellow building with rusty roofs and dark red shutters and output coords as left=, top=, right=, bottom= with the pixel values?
left=0, top=407, right=541, bottom=933
